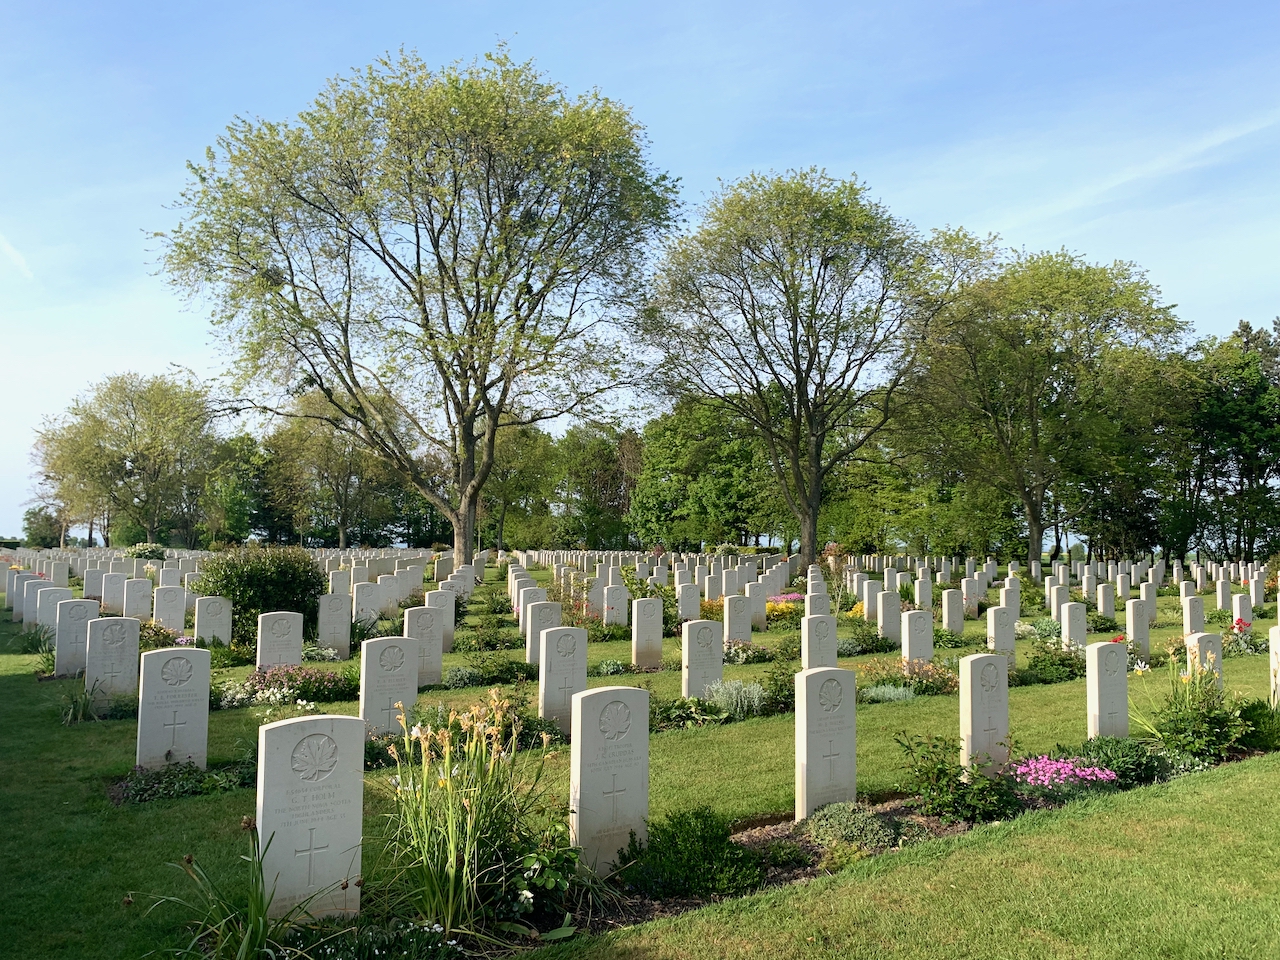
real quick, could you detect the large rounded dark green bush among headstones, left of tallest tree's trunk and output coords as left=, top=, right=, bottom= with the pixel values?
left=196, top=547, right=329, bottom=649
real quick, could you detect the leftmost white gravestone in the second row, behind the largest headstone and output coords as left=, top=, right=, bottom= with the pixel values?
left=136, top=646, right=209, bottom=769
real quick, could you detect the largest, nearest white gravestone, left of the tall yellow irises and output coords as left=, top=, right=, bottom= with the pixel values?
left=257, top=716, right=365, bottom=918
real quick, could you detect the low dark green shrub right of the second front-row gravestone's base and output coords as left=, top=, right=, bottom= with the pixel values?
left=614, top=806, right=764, bottom=899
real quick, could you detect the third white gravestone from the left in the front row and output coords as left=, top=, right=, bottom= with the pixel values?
left=795, top=667, right=858, bottom=820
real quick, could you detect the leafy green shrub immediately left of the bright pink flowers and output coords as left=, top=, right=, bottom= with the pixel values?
left=893, top=731, right=1021, bottom=823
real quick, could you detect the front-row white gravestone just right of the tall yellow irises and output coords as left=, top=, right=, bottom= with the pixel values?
left=570, top=686, right=649, bottom=876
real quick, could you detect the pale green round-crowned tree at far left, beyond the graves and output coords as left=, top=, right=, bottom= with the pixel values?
left=35, top=374, right=219, bottom=547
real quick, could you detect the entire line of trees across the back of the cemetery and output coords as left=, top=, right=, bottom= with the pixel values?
left=20, top=50, right=1280, bottom=561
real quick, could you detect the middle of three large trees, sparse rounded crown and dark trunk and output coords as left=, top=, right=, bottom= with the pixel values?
left=641, top=170, right=965, bottom=563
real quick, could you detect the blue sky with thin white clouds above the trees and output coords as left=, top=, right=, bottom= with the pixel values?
left=0, top=0, right=1280, bottom=535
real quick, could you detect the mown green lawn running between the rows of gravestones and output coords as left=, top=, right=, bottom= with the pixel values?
left=0, top=576, right=1280, bottom=959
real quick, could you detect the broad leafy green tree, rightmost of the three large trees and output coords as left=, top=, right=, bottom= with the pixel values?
left=899, top=252, right=1181, bottom=576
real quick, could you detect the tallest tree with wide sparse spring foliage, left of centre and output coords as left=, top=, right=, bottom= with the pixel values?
left=164, top=51, right=676, bottom=561
